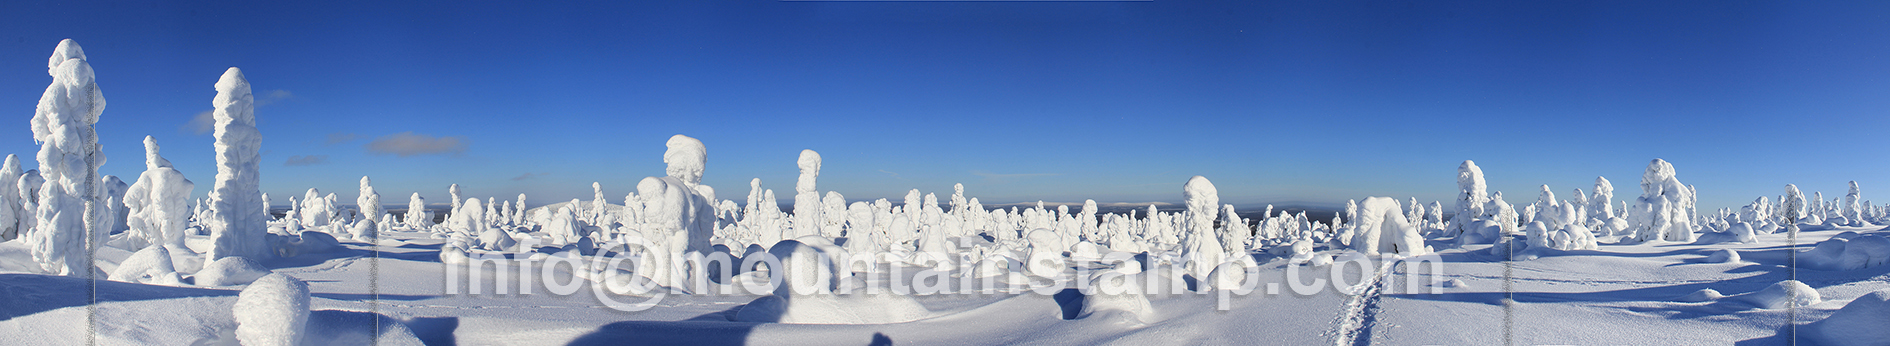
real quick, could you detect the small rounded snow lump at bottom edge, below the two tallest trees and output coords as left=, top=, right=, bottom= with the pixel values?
left=235, top=272, right=308, bottom=346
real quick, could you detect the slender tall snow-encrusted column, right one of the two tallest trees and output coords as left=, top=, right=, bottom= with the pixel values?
left=210, top=68, right=276, bottom=261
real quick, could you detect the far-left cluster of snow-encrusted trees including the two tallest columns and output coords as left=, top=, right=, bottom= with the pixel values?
left=0, top=40, right=302, bottom=285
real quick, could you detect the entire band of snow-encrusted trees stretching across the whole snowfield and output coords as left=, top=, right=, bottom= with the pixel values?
left=14, top=40, right=1890, bottom=294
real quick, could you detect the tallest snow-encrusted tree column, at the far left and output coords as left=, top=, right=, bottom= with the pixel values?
left=26, top=40, right=110, bottom=276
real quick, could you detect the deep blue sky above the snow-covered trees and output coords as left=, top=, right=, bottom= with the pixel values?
left=0, top=0, right=1890, bottom=208
